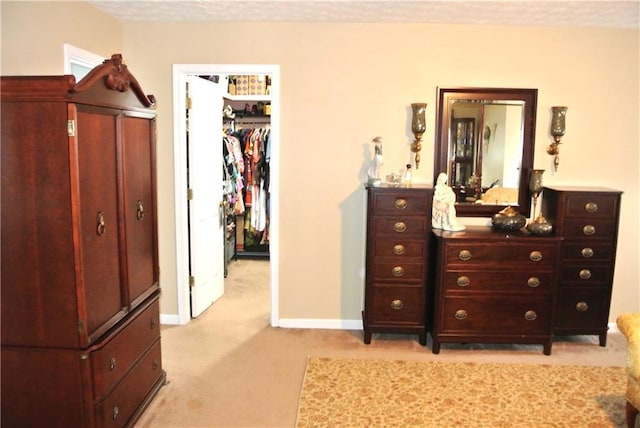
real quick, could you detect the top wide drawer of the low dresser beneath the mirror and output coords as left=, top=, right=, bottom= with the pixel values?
left=444, top=242, right=557, bottom=270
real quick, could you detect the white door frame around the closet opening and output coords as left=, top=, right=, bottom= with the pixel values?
left=173, top=64, right=280, bottom=327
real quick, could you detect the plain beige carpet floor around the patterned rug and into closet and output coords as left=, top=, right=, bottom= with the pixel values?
left=136, top=259, right=626, bottom=428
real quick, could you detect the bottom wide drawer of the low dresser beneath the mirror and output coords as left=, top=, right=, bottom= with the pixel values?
left=439, top=295, right=551, bottom=336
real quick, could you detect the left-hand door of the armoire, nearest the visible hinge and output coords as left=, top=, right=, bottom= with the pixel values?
left=71, top=106, right=123, bottom=341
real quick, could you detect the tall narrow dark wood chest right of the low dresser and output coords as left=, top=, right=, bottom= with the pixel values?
left=542, top=187, right=622, bottom=346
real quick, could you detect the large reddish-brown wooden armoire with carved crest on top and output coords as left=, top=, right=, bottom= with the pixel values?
left=1, top=55, right=166, bottom=427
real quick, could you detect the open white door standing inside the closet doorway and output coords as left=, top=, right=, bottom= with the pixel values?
left=187, top=76, right=225, bottom=317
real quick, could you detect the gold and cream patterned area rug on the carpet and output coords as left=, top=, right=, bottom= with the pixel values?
left=296, top=357, right=626, bottom=428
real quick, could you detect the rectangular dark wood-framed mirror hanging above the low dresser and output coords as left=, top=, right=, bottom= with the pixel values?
left=434, top=88, right=537, bottom=216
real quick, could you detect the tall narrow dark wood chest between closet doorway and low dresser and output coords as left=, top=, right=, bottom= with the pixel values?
left=362, top=185, right=433, bottom=345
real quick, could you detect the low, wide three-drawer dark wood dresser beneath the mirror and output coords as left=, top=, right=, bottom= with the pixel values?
left=430, top=226, right=561, bottom=355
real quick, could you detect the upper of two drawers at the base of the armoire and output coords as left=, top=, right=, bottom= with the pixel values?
left=89, top=298, right=160, bottom=400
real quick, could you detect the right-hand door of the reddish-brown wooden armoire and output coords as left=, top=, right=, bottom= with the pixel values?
left=122, top=114, right=159, bottom=306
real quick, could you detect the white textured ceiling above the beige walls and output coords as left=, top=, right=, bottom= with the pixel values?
left=87, top=0, right=640, bottom=28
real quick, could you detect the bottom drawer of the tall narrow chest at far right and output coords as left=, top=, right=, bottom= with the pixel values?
left=555, top=287, right=611, bottom=329
